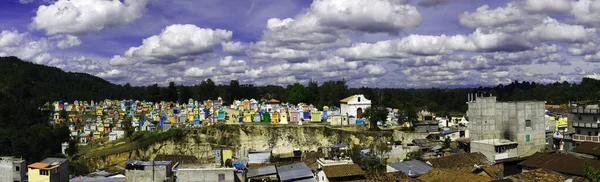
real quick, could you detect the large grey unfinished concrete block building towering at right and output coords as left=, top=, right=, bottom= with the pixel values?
left=467, top=93, right=546, bottom=162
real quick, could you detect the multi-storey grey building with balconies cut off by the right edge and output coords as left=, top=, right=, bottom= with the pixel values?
left=568, top=101, right=600, bottom=142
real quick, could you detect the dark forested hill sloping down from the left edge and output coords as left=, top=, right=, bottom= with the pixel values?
left=0, top=57, right=118, bottom=104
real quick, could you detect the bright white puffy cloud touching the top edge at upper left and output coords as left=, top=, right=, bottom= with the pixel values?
left=31, top=0, right=147, bottom=34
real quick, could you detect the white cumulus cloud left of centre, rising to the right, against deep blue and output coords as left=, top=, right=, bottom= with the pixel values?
left=110, top=24, right=232, bottom=65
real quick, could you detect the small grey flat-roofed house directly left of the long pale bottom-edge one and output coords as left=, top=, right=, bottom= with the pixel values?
left=125, top=160, right=174, bottom=182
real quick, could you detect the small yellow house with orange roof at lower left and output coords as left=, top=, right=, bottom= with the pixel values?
left=27, top=158, right=69, bottom=182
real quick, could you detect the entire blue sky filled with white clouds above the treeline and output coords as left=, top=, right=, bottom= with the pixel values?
left=0, top=0, right=600, bottom=88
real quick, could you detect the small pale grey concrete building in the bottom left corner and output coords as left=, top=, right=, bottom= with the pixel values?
left=0, top=157, right=27, bottom=182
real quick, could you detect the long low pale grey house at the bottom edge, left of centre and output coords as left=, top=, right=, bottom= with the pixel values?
left=173, top=164, right=239, bottom=182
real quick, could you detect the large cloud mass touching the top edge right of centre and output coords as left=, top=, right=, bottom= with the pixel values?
left=247, top=0, right=421, bottom=62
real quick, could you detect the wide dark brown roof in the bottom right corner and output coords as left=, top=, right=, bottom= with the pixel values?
left=519, top=152, right=600, bottom=177
